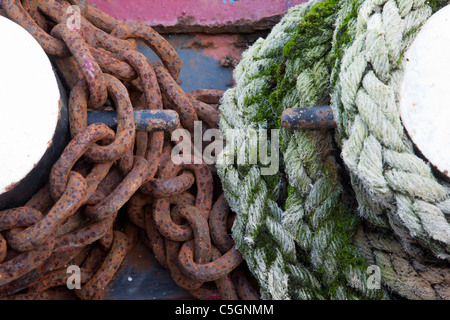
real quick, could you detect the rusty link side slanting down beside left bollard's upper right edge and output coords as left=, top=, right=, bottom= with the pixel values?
left=51, top=22, right=108, bottom=109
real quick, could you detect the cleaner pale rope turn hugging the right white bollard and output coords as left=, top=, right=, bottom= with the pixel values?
left=332, top=0, right=450, bottom=260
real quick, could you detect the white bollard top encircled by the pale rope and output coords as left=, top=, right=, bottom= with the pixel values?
left=400, top=6, right=450, bottom=177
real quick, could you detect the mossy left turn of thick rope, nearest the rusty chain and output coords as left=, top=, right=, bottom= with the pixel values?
left=219, top=1, right=380, bottom=299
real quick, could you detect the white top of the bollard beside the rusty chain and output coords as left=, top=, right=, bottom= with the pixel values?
left=0, top=16, right=60, bottom=194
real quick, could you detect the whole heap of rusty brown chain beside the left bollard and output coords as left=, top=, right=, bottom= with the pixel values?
left=0, top=0, right=259, bottom=300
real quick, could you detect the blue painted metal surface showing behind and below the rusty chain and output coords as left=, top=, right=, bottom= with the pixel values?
left=105, top=34, right=233, bottom=300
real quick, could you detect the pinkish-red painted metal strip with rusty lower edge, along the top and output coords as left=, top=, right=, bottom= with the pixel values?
left=91, top=0, right=305, bottom=33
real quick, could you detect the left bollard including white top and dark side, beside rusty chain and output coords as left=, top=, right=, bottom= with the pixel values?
left=0, top=16, right=68, bottom=210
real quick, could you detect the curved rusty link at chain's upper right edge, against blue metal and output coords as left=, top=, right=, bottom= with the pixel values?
left=111, top=21, right=181, bottom=81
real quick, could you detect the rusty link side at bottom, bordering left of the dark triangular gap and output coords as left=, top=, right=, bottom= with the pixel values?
left=76, top=230, right=128, bottom=300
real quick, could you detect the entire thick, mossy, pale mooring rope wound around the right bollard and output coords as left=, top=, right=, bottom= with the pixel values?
left=218, top=0, right=449, bottom=299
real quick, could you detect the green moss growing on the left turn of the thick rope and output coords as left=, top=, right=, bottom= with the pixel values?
left=222, top=0, right=394, bottom=298
